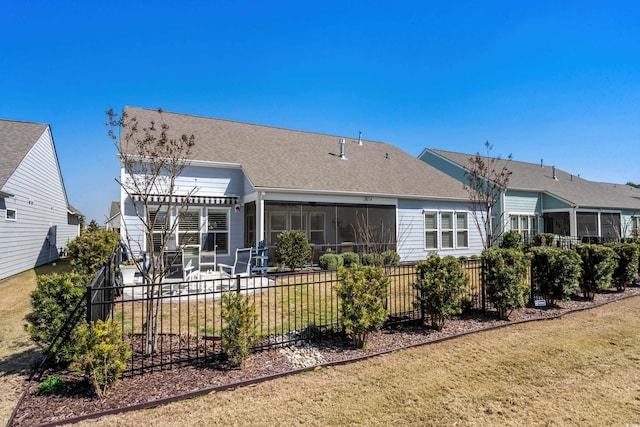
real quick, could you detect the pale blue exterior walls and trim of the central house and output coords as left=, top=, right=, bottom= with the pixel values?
left=121, top=166, right=482, bottom=264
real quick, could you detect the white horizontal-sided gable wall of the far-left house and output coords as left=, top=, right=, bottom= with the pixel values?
left=0, top=128, right=78, bottom=279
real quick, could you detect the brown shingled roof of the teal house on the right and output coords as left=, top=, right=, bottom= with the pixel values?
left=429, top=149, right=640, bottom=210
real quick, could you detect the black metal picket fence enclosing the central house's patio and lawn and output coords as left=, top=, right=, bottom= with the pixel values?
left=87, top=260, right=486, bottom=373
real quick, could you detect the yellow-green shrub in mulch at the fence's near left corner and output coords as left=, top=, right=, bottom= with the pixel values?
left=71, top=320, right=131, bottom=397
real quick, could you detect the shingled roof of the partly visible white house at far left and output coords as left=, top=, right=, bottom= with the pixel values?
left=0, top=119, right=47, bottom=189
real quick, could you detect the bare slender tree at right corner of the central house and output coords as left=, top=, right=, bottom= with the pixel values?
left=464, top=141, right=512, bottom=248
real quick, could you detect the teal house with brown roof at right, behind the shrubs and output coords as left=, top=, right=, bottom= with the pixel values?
left=419, top=149, right=640, bottom=243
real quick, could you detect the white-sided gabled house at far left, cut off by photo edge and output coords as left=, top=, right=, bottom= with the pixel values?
left=0, top=120, right=82, bottom=279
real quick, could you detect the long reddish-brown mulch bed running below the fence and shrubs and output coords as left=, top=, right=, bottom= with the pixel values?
left=11, top=287, right=640, bottom=426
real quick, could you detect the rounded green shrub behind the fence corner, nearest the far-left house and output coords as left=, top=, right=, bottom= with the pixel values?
left=67, top=230, right=119, bottom=276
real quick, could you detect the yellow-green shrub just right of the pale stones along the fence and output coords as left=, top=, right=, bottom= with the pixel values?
left=336, top=266, right=390, bottom=347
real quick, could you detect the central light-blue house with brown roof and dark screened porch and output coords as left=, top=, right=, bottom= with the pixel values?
left=121, top=107, right=482, bottom=270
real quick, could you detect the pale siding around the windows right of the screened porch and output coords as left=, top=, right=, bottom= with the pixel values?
left=397, top=200, right=482, bottom=261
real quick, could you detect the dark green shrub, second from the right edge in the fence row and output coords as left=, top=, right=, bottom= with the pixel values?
left=576, top=244, right=616, bottom=300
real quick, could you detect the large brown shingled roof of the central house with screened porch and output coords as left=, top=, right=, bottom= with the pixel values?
left=125, top=107, right=468, bottom=199
